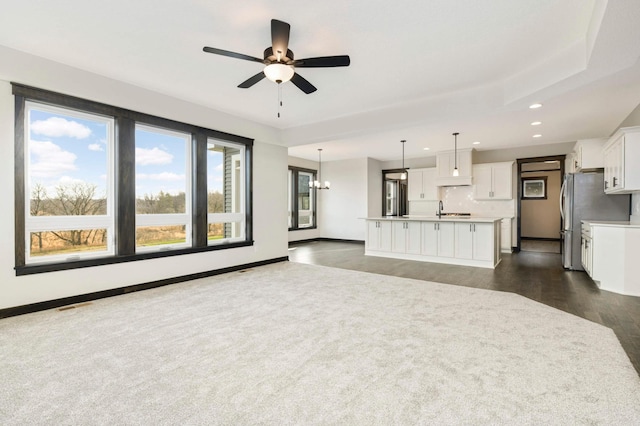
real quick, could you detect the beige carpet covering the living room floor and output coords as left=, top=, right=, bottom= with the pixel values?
left=0, top=262, right=640, bottom=425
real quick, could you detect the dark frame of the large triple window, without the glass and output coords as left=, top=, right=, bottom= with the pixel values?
left=11, top=82, right=253, bottom=276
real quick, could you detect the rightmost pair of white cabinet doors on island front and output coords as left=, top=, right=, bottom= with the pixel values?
left=455, top=222, right=494, bottom=260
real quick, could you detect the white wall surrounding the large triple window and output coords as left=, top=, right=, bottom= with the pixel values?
left=0, top=46, right=287, bottom=309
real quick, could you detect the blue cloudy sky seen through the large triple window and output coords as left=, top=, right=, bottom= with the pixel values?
left=28, top=106, right=222, bottom=201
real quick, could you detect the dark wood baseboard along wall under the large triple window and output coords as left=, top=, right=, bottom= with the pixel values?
left=0, top=256, right=289, bottom=319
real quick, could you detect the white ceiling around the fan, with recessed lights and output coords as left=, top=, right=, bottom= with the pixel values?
left=0, top=0, right=640, bottom=161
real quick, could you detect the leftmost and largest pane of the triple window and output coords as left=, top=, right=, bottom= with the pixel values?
left=24, top=102, right=114, bottom=263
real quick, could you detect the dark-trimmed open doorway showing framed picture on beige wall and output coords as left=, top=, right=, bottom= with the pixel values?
left=516, top=155, right=565, bottom=254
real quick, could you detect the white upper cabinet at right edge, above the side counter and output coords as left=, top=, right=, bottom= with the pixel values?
left=604, top=126, right=640, bottom=194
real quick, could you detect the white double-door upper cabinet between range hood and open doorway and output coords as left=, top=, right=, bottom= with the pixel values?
left=473, top=161, right=514, bottom=200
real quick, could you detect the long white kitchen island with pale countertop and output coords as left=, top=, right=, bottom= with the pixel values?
left=365, top=216, right=502, bottom=268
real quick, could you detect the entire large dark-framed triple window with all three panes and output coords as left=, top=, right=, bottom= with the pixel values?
left=13, top=84, right=253, bottom=275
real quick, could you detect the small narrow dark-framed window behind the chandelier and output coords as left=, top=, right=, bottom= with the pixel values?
left=289, top=167, right=316, bottom=230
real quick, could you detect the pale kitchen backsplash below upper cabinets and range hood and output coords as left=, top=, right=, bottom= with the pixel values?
left=409, top=186, right=516, bottom=217
